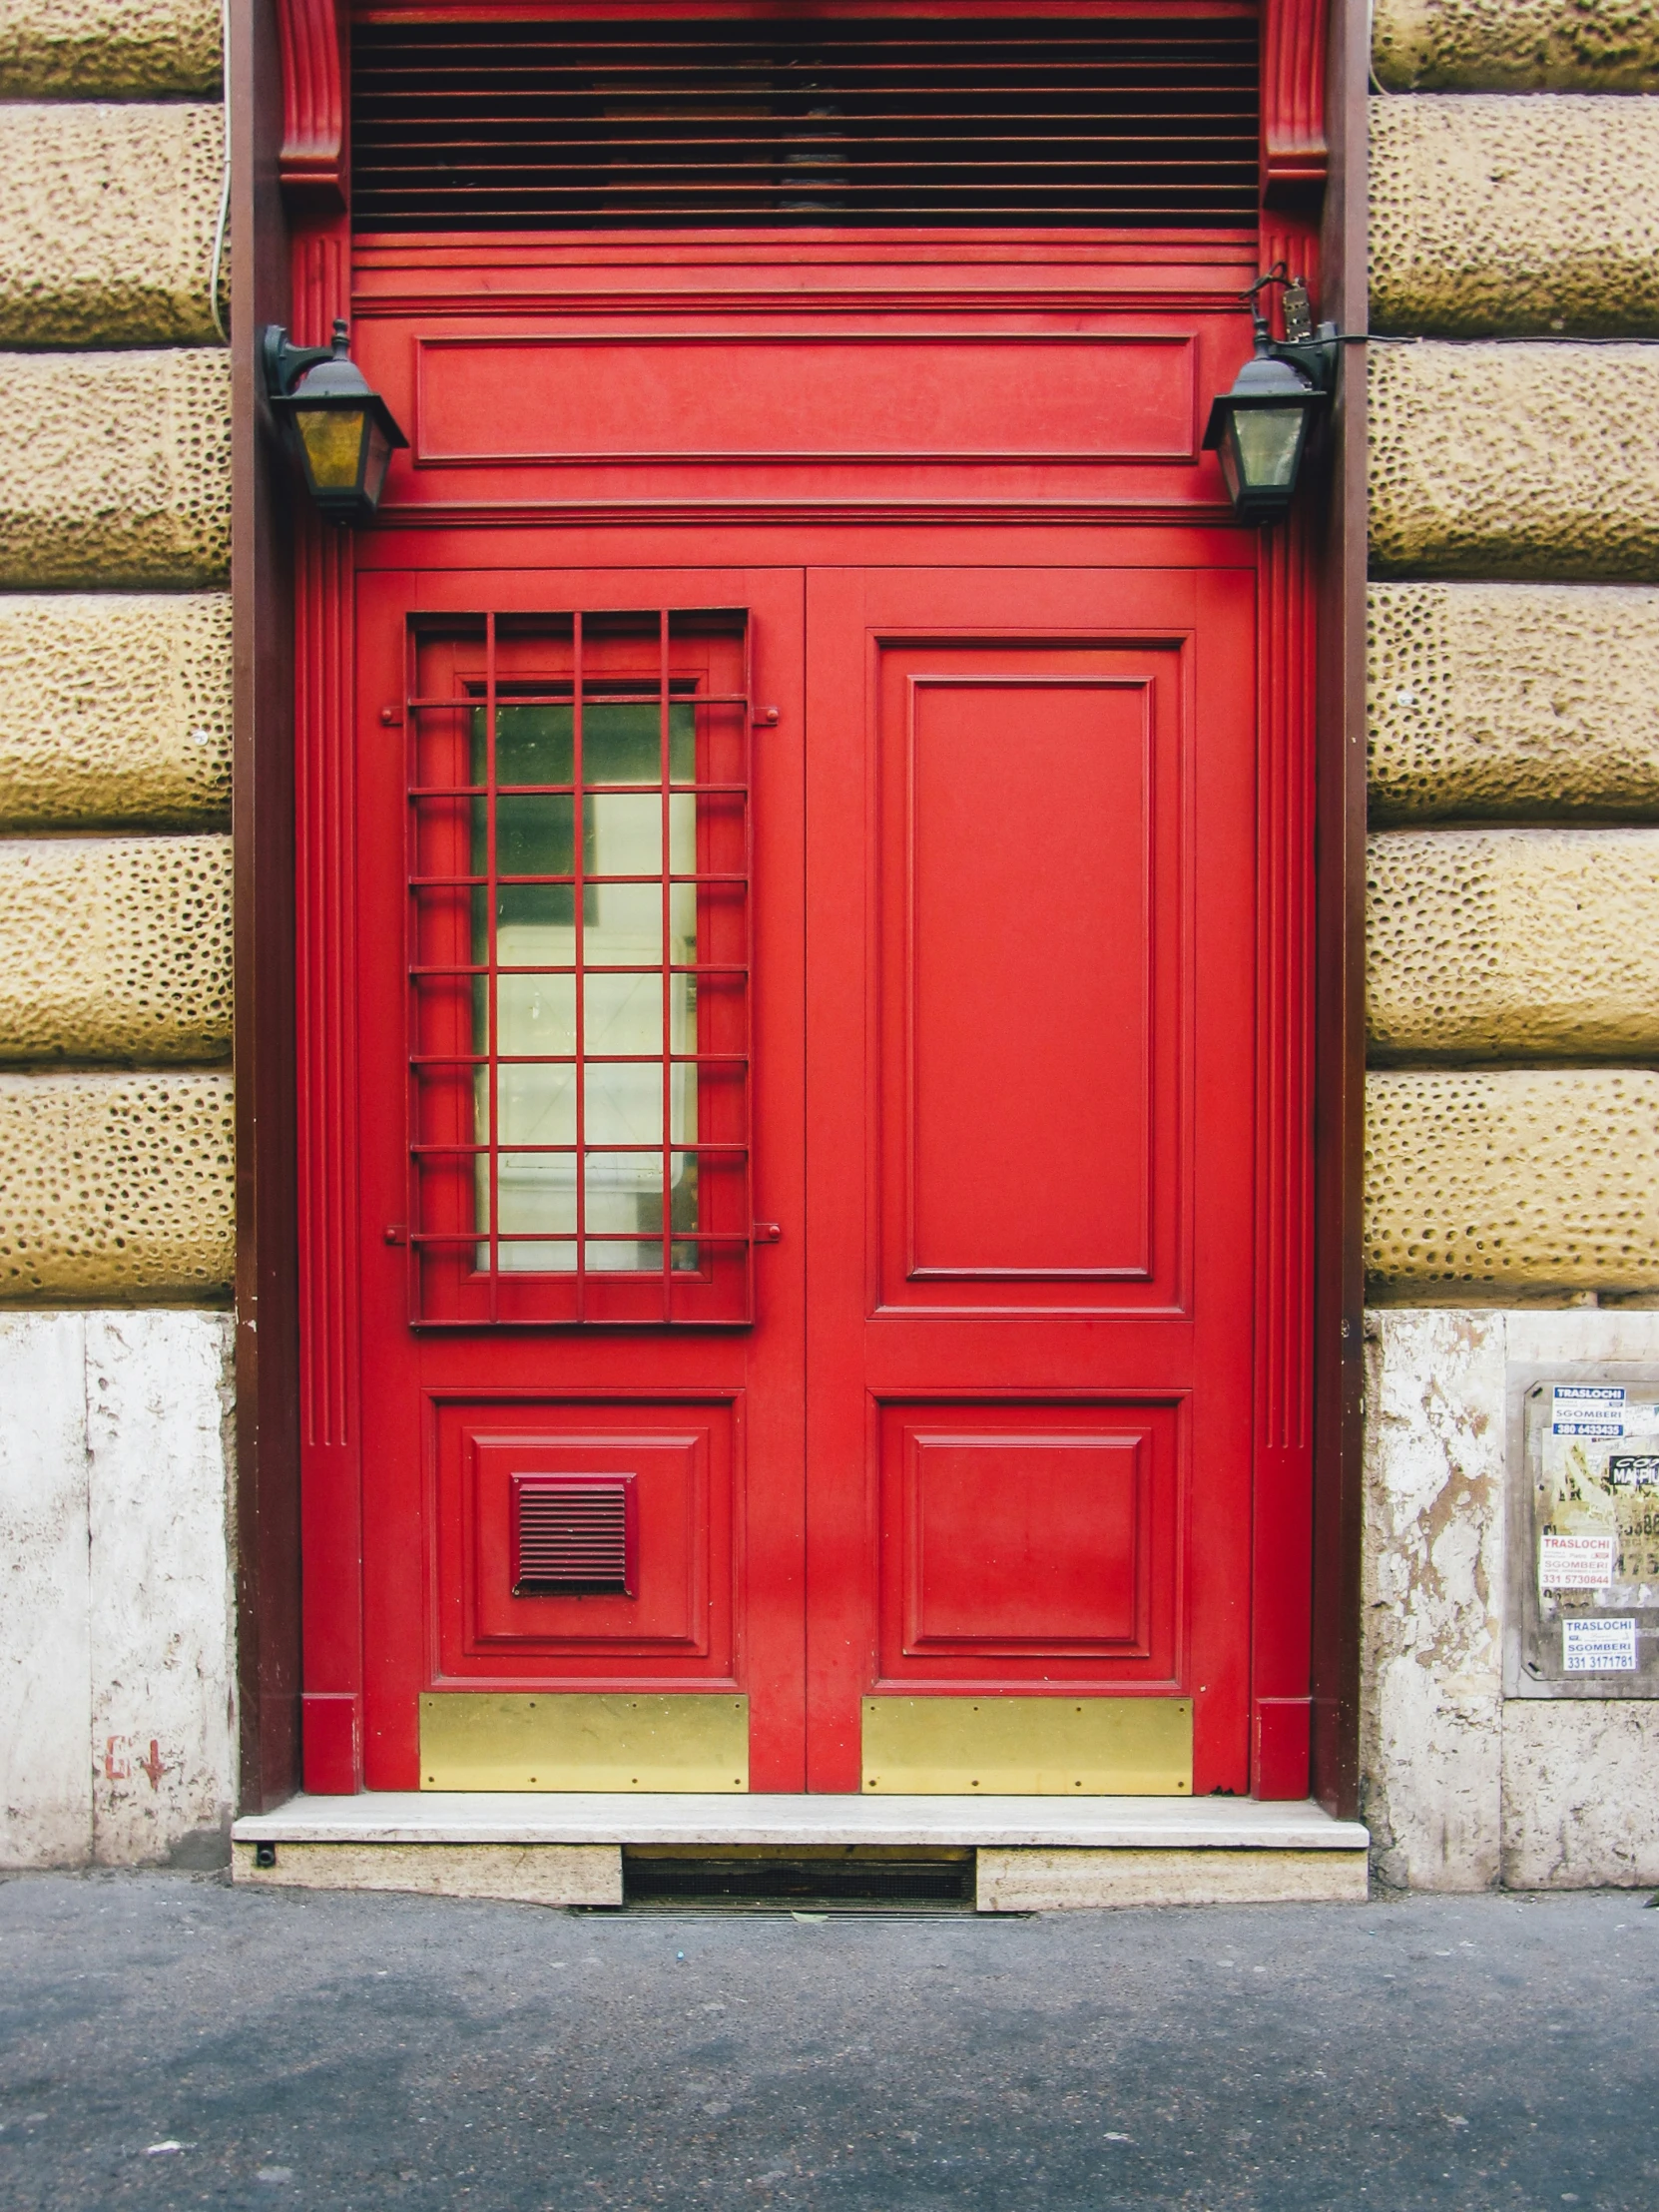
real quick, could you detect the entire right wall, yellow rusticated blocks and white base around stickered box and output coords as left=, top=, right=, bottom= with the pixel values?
left=1361, top=0, right=1659, bottom=1889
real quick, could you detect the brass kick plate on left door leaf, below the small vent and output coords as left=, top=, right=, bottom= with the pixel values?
left=420, top=1690, right=750, bottom=1792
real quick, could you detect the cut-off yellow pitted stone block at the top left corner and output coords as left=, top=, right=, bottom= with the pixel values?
left=0, top=0, right=219, bottom=100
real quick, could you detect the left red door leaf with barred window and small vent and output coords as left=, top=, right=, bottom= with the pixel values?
left=354, top=566, right=806, bottom=1790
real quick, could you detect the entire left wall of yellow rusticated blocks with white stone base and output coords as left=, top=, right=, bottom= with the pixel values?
left=0, top=0, right=235, bottom=1867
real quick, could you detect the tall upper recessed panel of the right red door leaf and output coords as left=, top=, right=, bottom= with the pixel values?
left=897, top=637, right=1181, bottom=1301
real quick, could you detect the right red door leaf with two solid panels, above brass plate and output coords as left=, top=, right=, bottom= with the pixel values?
left=808, top=569, right=1254, bottom=1792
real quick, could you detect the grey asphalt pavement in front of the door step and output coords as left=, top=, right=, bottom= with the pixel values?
left=0, top=1874, right=1659, bottom=2212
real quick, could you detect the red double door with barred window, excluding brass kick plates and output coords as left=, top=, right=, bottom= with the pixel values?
left=356, top=553, right=1257, bottom=1794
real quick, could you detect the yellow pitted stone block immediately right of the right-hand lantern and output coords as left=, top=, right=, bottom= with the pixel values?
left=1370, top=340, right=1659, bottom=582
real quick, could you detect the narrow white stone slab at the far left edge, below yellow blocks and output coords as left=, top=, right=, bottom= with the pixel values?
left=0, top=1314, right=93, bottom=1867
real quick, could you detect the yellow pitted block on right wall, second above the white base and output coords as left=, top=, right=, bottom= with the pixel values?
left=1365, top=830, right=1659, bottom=1059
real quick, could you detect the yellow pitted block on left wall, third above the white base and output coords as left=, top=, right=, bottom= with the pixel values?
left=0, top=591, right=230, bottom=830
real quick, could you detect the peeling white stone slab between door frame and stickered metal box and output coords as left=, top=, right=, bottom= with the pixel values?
left=1361, top=1312, right=1504, bottom=1889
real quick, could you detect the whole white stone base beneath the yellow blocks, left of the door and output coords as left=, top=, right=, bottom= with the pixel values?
left=0, top=1312, right=235, bottom=1867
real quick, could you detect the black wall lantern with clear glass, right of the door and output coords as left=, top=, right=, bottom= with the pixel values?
left=1204, top=261, right=1341, bottom=524
